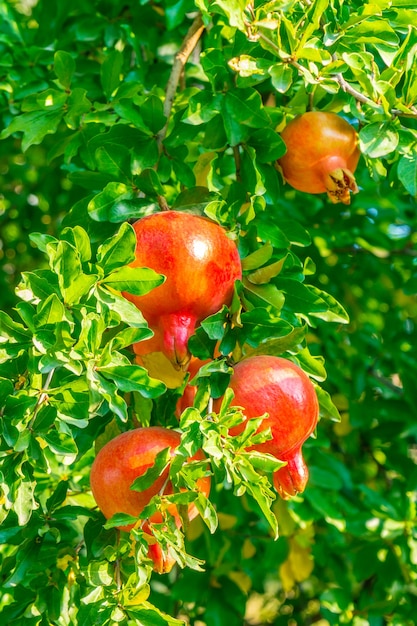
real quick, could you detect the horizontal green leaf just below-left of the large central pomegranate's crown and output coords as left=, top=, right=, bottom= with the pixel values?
left=97, top=365, right=166, bottom=398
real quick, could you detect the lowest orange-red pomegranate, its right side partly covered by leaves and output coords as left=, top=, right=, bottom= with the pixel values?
left=90, top=426, right=211, bottom=573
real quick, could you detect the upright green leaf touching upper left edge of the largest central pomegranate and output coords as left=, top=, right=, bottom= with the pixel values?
left=97, top=222, right=136, bottom=274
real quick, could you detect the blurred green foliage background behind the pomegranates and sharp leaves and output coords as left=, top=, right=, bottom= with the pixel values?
left=0, top=0, right=417, bottom=626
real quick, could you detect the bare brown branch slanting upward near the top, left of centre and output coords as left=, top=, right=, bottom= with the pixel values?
left=158, top=14, right=205, bottom=147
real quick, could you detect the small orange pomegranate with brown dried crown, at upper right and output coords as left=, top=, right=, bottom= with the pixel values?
left=278, top=111, right=360, bottom=204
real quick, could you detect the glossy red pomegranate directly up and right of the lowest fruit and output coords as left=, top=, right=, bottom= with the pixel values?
left=214, top=355, right=319, bottom=499
